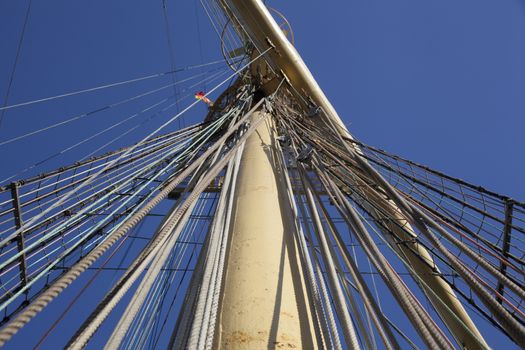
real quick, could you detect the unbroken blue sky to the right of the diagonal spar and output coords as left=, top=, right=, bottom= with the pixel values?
left=275, top=0, right=525, bottom=202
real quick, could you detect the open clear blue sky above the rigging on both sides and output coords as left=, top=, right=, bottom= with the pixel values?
left=0, top=0, right=525, bottom=345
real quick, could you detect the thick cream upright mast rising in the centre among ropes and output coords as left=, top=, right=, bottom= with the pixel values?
left=215, top=106, right=316, bottom=349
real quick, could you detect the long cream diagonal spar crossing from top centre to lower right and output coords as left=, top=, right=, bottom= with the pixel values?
left=218, top=0, right=487, bottom=349
